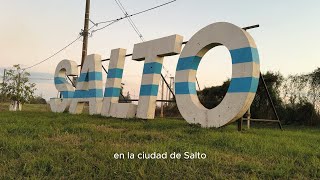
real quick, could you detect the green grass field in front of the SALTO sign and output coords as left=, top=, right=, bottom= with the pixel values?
left=0, top=105, right=320, bottom=179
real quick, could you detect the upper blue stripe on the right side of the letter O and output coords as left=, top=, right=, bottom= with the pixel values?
left=230, top=47, right=259, bottom=64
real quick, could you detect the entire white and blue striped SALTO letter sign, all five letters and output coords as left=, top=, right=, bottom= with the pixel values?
left=50, top=22, right=260, bottom=127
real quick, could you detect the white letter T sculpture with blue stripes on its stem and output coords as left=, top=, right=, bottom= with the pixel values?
left=132, top=35, right=183, bottom=119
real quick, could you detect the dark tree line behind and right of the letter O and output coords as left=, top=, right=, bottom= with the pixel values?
left=198, top=68, right=320, bottom=126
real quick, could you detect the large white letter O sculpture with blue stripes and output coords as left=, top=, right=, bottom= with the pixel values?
left=175, top=22, right=260, bottom=127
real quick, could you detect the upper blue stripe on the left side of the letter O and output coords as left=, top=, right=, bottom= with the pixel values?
left=177, top=56, right=201, bottom=71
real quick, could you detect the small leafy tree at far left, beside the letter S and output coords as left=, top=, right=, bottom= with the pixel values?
left=1, top=65, right=36, bottom=109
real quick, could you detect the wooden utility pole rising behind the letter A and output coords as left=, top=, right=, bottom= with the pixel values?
left=81, top=0, right=90, bottom=69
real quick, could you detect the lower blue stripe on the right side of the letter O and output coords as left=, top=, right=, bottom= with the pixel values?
left=228, top=77, right=259, bottom=93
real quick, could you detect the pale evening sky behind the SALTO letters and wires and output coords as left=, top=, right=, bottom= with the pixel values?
left=0, top=0, right=320, bottom=100
